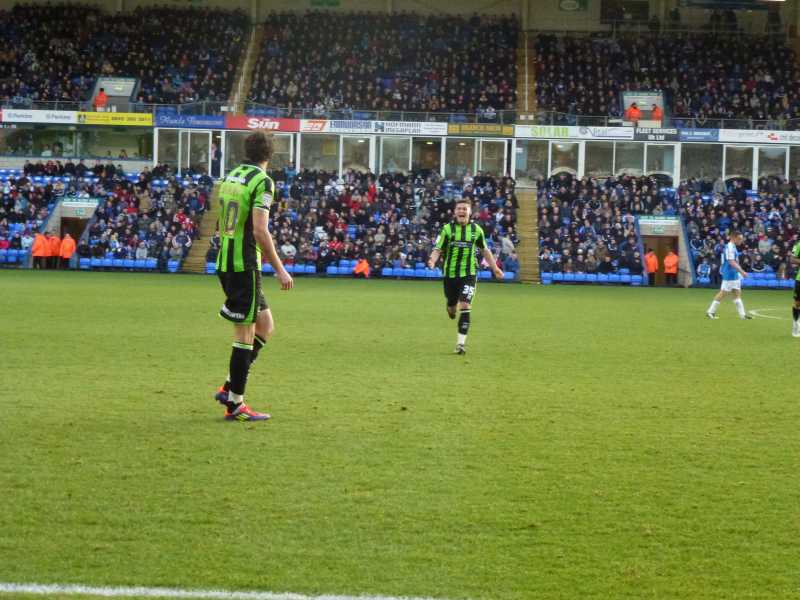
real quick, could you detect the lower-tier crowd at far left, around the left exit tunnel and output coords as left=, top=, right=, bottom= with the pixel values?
left=0, top=161, right=213, bottom=269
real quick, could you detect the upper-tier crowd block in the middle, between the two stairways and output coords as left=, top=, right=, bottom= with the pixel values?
left=250, top=12, right=519, bottom=116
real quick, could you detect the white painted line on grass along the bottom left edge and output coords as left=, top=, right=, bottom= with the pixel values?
left=0, top=583, right=450, bottom=600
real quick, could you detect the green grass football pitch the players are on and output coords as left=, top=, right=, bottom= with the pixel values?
left=0, top=271, right=800, bottom=600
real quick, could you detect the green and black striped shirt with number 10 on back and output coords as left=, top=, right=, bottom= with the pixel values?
left=217, top=165, right=275, bottom=271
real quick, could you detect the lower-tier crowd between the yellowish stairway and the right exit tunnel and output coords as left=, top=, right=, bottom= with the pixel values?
left=538, top=174, right=652, bottom=275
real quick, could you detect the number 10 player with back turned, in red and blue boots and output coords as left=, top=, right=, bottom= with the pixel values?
left=215, top=131, right=294, bottom=421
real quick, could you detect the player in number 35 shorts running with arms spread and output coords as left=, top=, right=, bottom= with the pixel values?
left=428, top=199, right=503, bottom=354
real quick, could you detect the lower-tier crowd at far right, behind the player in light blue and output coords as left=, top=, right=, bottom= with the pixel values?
left=679, top=179, right=800, bottom=285
